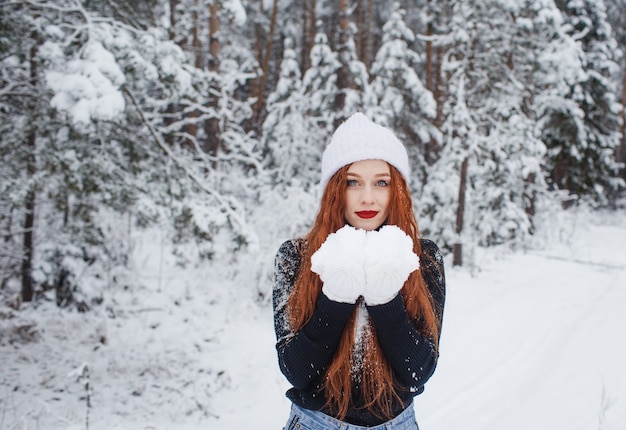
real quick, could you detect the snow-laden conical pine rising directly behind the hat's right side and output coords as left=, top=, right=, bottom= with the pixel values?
left=367, top=2, right=440, bottom=187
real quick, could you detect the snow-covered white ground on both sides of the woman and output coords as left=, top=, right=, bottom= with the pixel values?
left=0, top=207, right=626, bottom=430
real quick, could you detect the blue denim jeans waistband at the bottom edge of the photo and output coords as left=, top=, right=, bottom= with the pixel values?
left=283, top=404, right=419, bottom=430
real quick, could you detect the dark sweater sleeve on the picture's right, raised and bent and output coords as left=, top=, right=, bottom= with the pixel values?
left=368, top=241, right=445, bottom=392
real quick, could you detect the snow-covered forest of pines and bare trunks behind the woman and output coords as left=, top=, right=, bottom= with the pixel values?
left=0, top=0, right=626, bottom=427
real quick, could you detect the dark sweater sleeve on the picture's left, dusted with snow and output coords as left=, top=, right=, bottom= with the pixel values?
left=273, top=242, right=355, bottom=389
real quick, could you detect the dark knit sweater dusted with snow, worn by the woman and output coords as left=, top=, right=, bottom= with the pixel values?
left=273, top=239, right=445, bottom=426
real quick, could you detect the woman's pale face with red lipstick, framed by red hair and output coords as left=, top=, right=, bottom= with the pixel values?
left=344, top=160, right=391, bottom=230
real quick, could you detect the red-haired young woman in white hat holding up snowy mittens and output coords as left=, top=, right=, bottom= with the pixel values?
left=273, top=113, right=445, bottom=430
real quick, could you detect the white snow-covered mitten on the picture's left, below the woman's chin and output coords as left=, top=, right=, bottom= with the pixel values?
left=311, top=225, right=365, bottom=303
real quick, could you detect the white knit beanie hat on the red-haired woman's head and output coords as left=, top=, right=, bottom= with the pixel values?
left=320, top=112, right=411, bottom=191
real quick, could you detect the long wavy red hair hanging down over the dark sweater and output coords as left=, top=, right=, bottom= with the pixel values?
left=287, top=165, right=439, bottom=420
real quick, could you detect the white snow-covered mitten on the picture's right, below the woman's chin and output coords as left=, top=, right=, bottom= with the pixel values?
left=363, top=225, right=419, bottom=305
